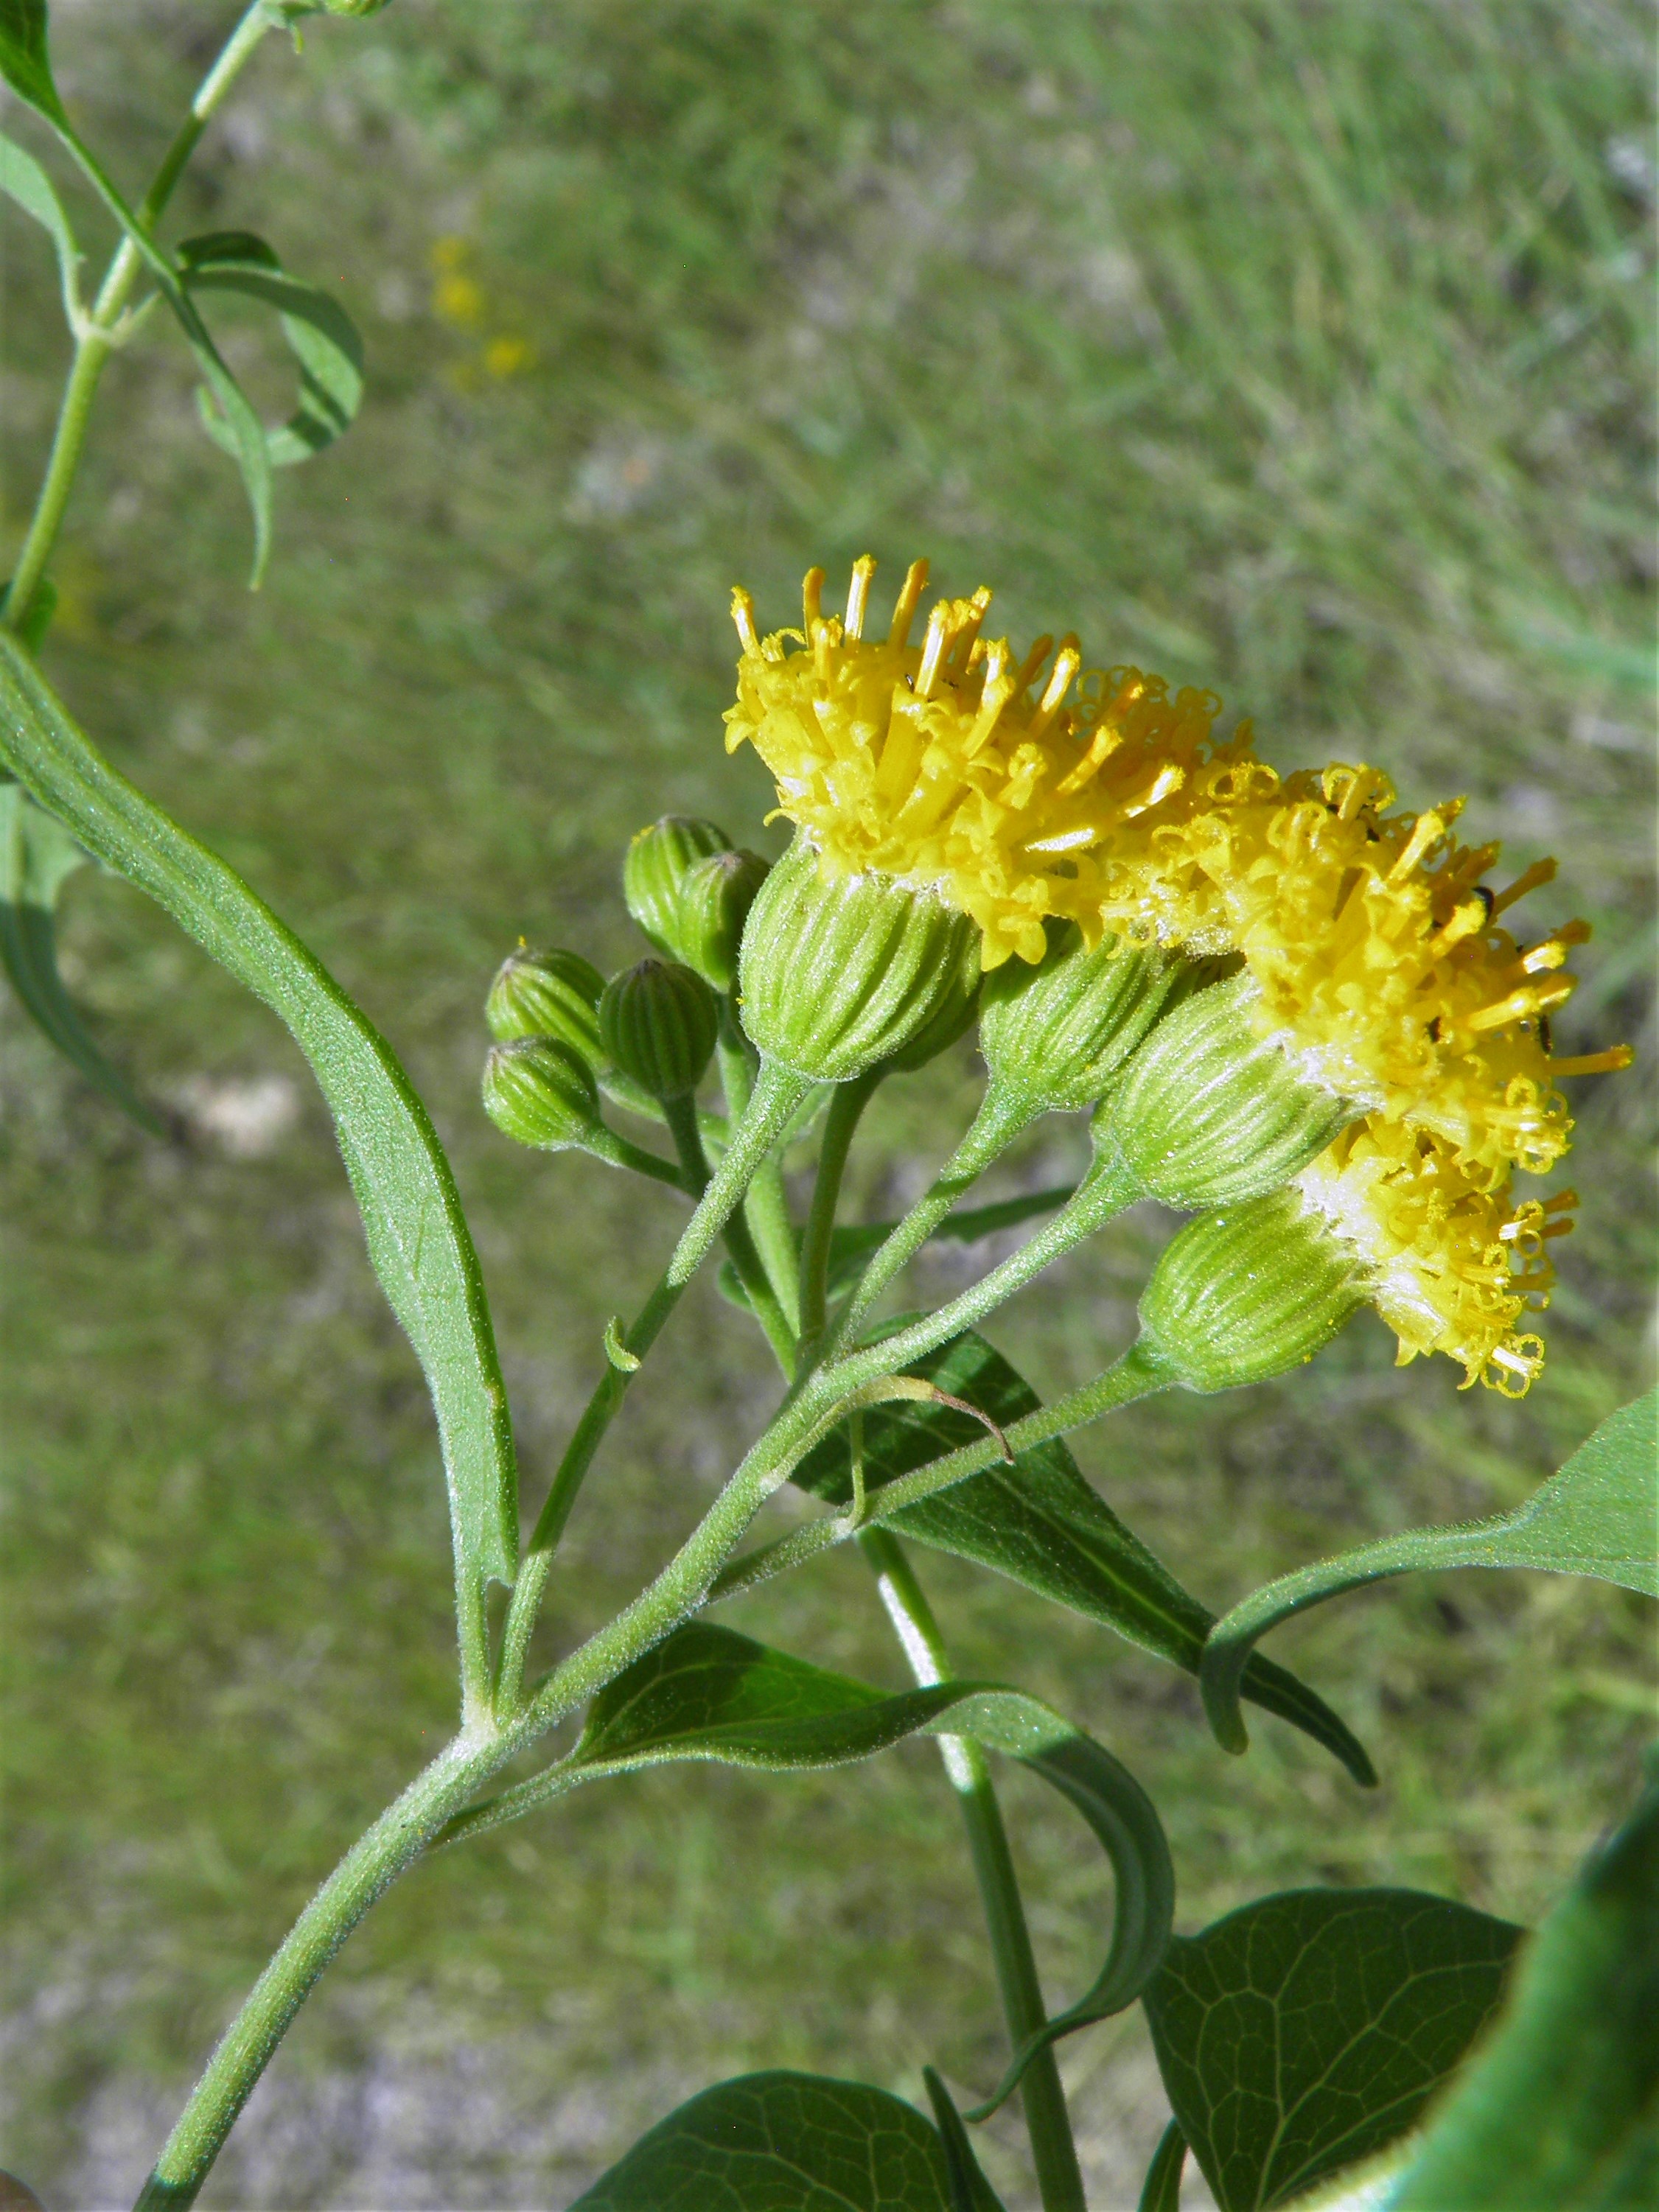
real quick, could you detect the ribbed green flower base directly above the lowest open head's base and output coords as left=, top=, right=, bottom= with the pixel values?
left=1097, top=976, right=1358, bottom=1210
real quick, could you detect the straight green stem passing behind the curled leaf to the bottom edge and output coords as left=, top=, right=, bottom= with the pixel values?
left=859, top=1528, right=1086, bottom=2212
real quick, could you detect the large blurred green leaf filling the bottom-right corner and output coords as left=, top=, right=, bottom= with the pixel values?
left=1385, top=1785, right=1659, bottom=2212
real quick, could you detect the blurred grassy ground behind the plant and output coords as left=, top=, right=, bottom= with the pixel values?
left=0, top=0, right=1655, bottom=2208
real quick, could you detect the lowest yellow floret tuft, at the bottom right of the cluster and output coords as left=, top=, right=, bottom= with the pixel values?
left=1294, top=1117, right=1577, bottom=1398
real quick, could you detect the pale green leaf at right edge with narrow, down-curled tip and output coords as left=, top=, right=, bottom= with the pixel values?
left=1199, top=1391, right=1659, bottom=1752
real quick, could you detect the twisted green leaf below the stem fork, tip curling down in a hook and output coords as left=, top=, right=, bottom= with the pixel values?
left=438, top=1621, right=1175, bottom=2104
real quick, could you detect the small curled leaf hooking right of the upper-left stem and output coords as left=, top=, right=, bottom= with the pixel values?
left=179, top=230, right=363, bottom=469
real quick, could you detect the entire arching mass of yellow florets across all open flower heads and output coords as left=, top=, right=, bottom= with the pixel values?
left=725, top=558, right=1628, bottom=1389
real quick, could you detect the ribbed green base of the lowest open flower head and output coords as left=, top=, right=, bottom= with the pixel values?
left=1142, top=1190, right=1365, bottom=1391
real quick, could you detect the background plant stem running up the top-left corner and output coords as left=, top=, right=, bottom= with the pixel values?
left=0, top=0, right=276, bottom=633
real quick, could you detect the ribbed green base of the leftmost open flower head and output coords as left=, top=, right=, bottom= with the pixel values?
left=738, top=839, right=980, bottom=1084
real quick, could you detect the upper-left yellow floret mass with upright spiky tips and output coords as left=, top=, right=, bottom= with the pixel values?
left=725, top=558, right=1250, bottom=969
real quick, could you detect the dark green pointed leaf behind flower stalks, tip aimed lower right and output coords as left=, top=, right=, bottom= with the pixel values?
left=794, top=1331, right=1376, bottom=1785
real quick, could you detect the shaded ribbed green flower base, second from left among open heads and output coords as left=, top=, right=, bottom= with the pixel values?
left=980, top=923, right=1181, bottom=1113
